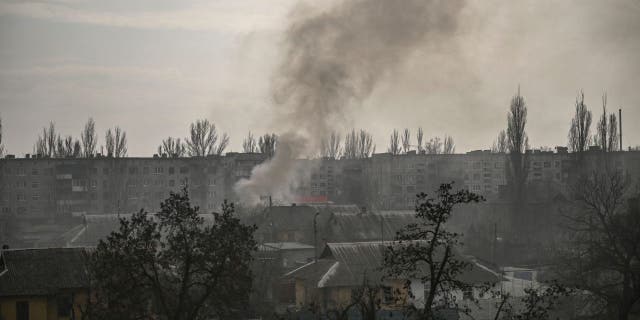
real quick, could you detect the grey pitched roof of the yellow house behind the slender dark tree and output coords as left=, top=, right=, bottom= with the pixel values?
left=285, top=241, right=500, bottom=287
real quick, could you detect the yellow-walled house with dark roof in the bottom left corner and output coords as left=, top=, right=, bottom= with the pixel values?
left=0, top=248, right=89, bottom=320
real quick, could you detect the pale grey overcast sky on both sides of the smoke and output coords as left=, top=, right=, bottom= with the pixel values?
left=0, top=0, right=640, bottom=156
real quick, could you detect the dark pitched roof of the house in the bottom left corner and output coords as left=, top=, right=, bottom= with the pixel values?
left=0, top=248, right=89, bottom=296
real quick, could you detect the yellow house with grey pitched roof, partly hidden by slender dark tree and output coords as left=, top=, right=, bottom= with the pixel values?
left=285, top=241, right=501, bottom=311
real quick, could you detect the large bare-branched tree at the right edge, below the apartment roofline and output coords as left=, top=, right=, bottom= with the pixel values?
left=555, top=169, right=640, bottom=319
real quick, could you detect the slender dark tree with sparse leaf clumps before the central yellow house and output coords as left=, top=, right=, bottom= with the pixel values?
left=384, top=184, right=484, bottom=319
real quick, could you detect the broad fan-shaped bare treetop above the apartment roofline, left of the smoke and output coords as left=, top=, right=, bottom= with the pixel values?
left=185, top=119, right=229, bottom=157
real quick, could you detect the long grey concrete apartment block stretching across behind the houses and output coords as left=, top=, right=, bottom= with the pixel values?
left=0, top=148, right=640, bottom=218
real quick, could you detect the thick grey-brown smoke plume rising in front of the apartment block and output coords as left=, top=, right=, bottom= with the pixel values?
left=235, top=0, right=463, bottom=204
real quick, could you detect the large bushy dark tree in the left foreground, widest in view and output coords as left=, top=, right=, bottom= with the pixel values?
left=87, top=188, right=256, bottom=320
